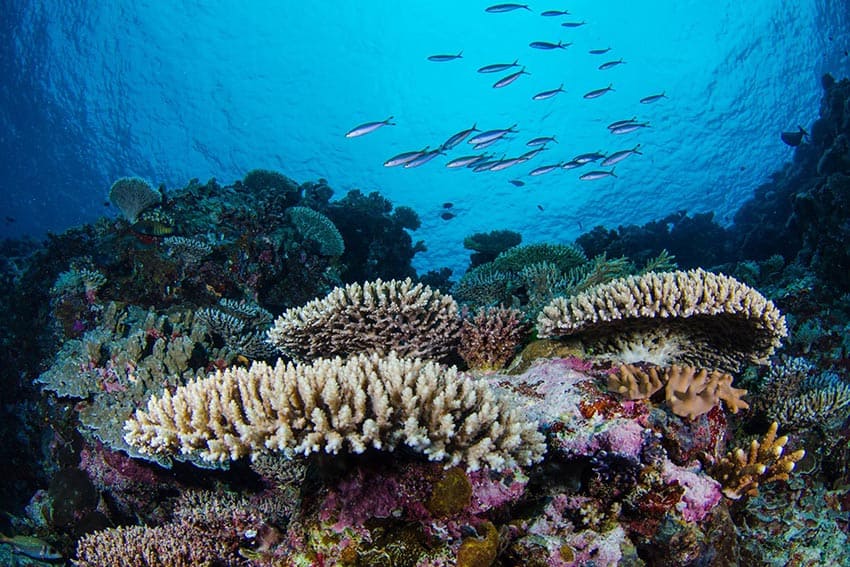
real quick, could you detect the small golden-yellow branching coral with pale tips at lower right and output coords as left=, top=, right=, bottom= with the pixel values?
left=710, top=421, right=806, bottom=500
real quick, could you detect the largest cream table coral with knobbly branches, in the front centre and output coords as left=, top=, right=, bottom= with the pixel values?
left=125, top=353, right=545, bottom=470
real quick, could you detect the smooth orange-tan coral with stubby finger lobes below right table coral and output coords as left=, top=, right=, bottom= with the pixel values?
left=608, top=364, right=749, bottom=419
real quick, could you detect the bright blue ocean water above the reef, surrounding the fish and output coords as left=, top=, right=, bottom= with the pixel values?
left=0, top=0, right=850, bottom=273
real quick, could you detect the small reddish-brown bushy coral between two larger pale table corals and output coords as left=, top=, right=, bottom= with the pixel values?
left=458, top=307, right=529, bottom=370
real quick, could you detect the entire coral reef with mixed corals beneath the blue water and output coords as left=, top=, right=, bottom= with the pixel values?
left=0, top=71, right=850, bottom=567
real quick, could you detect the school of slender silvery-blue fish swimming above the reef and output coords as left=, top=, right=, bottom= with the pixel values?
left=345, top=3, right=668, bottom=213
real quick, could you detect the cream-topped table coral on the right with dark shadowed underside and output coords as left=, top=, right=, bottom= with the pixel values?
left=537, top=269, right=787, bottom=371
